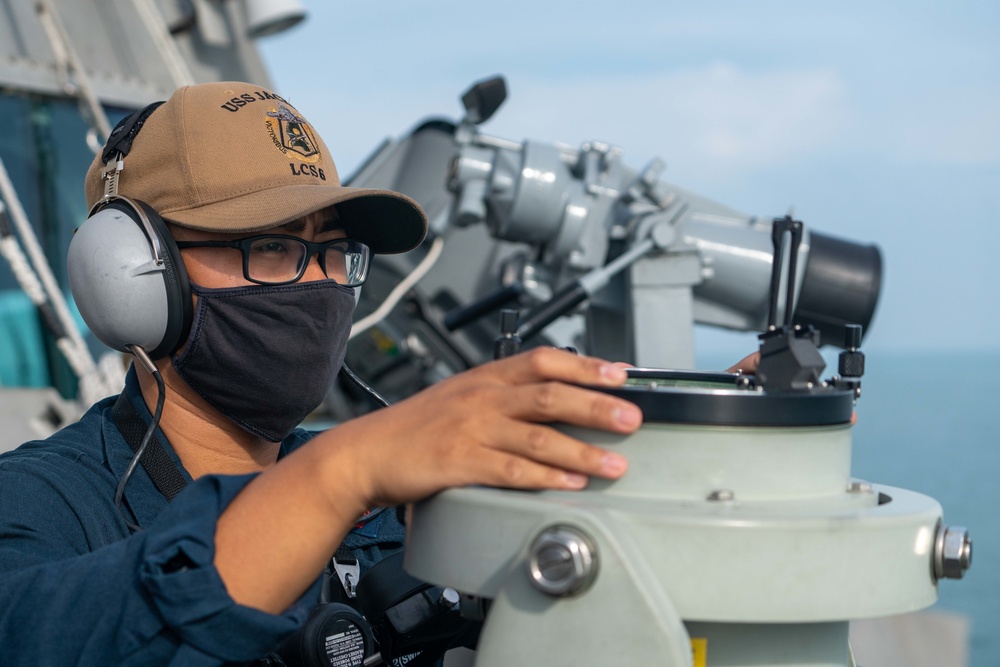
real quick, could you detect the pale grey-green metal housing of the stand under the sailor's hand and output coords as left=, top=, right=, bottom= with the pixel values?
left=406, top=424, right=942, bottom=667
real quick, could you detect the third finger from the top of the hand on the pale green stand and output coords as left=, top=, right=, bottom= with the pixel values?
left=482, top=422, right=628, bottom=479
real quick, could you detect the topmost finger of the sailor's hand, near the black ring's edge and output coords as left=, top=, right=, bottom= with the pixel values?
left=480, top=347, right=628, bottom=387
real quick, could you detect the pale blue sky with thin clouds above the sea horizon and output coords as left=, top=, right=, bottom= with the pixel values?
left=258, top=0, right=1000, bottom=352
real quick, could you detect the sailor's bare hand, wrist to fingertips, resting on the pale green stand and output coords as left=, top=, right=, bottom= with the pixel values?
left=330, top=348, right=642, bottom=505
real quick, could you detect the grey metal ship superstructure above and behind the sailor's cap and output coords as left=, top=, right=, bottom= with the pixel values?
left=0, top=0, right=268, bottom=108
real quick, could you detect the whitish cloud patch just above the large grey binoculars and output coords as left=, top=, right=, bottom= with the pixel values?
left=484, top=62, right=851, bottom=175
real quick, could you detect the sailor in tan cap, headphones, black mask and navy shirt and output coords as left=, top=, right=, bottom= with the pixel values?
left=0, top=82, right=642, bottom=666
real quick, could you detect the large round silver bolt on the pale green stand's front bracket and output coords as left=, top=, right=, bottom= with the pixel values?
left=528, top=526, right=598, bottom=596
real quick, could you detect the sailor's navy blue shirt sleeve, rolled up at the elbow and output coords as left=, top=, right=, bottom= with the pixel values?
left=0, top=462, right=315, bottom=666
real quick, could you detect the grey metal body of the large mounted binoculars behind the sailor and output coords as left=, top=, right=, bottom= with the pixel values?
left=340, top=106, right=877, bottom=394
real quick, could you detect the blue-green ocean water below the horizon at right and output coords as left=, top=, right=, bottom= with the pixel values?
left=699, top=351, right=1000, bottom=667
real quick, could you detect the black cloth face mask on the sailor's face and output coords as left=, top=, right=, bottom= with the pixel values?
left=172, top=280, right=355, bottom=442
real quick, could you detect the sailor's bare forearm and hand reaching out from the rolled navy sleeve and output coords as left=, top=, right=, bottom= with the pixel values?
left=215, top=348, right=641, bottom=612
